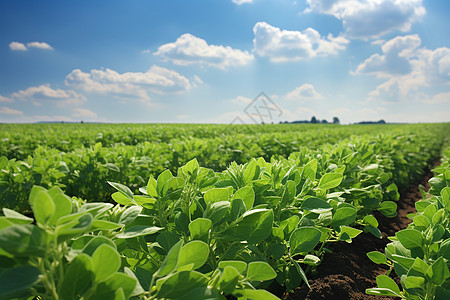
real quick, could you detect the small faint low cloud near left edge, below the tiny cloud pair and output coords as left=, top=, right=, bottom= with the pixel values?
left=10, top=84, right=87, bottom=106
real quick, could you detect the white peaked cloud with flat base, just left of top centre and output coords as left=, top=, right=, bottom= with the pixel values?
left=154, top=33, right=254, bottom=69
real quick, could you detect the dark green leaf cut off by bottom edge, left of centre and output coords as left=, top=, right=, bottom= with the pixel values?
left=156, top=271, right=208, bottom=299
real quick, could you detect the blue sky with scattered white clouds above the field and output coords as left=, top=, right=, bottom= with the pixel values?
left=0, top=0, right=450, bottom=124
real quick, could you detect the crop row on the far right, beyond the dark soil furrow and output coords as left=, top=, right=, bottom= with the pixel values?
left=366, top=147, right=450, bottom=300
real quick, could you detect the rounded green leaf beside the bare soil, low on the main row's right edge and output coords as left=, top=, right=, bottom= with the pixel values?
left=289, top=227, right=322, bottom=255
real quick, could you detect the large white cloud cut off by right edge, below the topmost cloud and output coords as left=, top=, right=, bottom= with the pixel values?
left=353, top=35, right=450, bottom=101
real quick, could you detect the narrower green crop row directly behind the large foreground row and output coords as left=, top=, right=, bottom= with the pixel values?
left=0, top=124, right=448, bottom=212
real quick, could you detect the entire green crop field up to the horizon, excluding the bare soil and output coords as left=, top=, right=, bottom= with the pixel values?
left=0, top=123, right=450, bottom=299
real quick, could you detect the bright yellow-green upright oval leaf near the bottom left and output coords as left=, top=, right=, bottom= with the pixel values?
left=92, top=244, right=122, bottom=282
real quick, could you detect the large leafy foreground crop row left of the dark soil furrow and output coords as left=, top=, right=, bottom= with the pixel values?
left=0, top=127, right=443, bottom=299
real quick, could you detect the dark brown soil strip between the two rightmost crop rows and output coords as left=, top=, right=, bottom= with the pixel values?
left=283, top=162, right=438, bottom=300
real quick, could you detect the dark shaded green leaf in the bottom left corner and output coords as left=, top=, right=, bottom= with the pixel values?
left=0, top=266, right=40, bottom=299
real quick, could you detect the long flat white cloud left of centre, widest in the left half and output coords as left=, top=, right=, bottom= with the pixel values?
left=65, top=66, right=192, bottom=100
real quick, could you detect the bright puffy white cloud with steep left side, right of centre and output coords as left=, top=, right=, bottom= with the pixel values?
left=253, top=22, right=348, bottom=62
